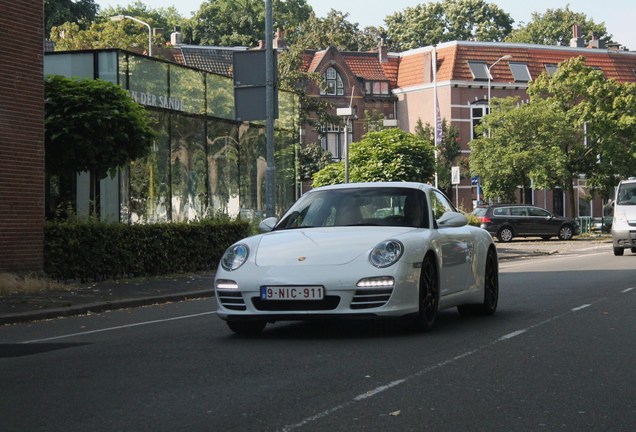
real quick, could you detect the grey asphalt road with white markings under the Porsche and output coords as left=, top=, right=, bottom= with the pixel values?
left=0, top=241, right=636, bottom=432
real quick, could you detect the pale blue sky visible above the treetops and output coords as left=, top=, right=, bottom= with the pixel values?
left=96, top=0, right=636, bottom=51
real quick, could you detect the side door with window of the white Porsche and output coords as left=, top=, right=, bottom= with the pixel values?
left=429, top=191, right=474, bottom=296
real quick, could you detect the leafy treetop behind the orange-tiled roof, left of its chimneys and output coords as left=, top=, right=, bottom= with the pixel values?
left=384, top=0, right=514, bottom=51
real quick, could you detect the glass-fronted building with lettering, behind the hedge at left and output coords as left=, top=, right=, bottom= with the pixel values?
left=44, top=50, right=299, bottom=223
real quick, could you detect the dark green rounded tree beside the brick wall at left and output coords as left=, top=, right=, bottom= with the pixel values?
left=44, top=76, right=156, bottom=216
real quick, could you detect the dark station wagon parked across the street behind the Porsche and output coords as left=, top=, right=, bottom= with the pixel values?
left=473, top=204, right=580, bottom=242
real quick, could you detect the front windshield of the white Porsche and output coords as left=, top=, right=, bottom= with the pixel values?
left=274, top=187, right=429, bottom=230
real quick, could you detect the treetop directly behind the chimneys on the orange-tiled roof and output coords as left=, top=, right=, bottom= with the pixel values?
left=506, top=5, right=612, bottom=46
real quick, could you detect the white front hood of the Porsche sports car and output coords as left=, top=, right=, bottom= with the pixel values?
left=255, top=227, right=415, bottom=267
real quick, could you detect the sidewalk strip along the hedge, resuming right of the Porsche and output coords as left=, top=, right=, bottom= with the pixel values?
left=0, top=237, right=611, bottom=325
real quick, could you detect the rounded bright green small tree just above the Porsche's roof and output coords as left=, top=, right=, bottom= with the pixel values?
left=313, top=128, right=435, bottom=187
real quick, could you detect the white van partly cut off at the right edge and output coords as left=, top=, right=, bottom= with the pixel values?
left=612, top=177, right=636, bottom=255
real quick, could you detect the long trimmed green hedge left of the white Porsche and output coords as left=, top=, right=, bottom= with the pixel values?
left=44, top=219, right=250, bottom=281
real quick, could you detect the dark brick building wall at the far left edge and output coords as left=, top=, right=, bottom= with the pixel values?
left=0, top=0, right=44, bottom=272
